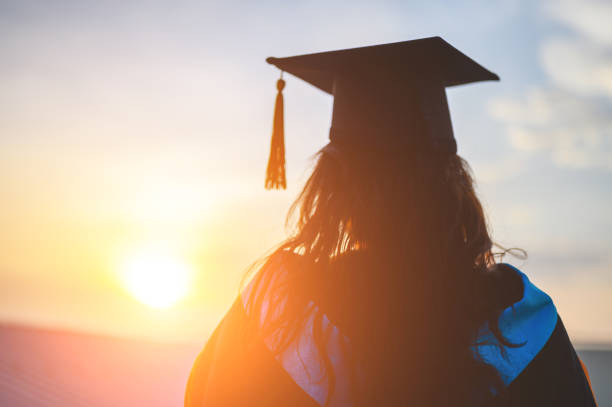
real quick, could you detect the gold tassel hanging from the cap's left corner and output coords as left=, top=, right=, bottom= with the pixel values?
left=266, top=72, right=287, bottom=189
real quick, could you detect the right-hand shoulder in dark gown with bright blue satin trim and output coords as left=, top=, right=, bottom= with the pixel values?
left=475, top=265, right=596, bottom=407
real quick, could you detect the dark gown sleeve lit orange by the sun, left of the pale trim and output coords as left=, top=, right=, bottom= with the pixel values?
left=184, top=255, right=318, bottom=407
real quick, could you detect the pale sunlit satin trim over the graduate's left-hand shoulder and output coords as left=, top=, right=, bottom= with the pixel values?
left=241, top=253, right=351, bottom=406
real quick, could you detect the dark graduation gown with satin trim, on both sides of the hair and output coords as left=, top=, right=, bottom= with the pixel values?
left=185, top=266, right=596, bottom=407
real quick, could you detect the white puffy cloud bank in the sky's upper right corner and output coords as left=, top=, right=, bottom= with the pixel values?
left=489, top=0, right=612, bottom=170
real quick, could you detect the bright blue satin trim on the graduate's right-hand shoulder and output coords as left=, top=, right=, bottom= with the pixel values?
left=473, top=266, right=557, bottom=386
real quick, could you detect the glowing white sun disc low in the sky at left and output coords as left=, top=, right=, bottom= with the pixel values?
left=121, top=250, right=192, bottom=308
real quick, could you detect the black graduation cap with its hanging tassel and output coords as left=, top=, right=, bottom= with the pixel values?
left=266, top=37, right=499, bottom=189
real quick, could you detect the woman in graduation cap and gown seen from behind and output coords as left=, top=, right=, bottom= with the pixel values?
left=185, top=37, right=596, bottom=407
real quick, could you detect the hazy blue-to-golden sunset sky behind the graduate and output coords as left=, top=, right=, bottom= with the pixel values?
left=0, top=0, right=612, bottom=344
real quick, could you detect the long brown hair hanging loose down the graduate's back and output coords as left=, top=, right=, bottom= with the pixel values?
left=241, top=143, right=520, bottom=406
